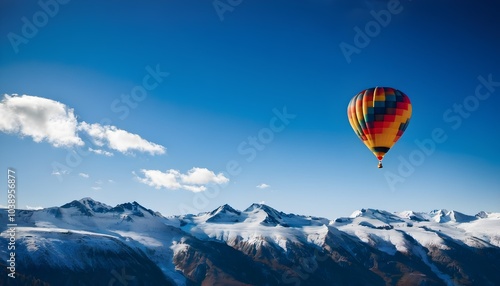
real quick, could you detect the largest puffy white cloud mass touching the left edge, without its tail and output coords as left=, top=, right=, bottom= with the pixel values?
left=0, top=94, right=84, bottom=147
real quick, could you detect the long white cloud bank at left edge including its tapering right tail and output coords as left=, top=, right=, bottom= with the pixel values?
left=0, top=94, right=165, bottom=157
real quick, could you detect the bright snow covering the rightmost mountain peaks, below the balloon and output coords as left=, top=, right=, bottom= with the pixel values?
left=331, top=209, right=500, bottom=254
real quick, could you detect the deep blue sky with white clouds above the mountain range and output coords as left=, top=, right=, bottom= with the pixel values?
left=0, top=0, right=500, bottom=218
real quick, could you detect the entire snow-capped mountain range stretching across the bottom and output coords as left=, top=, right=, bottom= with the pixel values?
left=0, top=198, right=500, bottom=285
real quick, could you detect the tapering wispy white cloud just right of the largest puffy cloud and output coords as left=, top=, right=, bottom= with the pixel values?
left=78, top=122, right=165, bottom=155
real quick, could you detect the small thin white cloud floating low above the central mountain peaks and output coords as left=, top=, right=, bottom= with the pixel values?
left=137, top=167, right=229, bottom=193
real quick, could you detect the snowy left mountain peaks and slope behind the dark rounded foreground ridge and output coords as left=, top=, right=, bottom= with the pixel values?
left=0, top=198, right=185, bottom=285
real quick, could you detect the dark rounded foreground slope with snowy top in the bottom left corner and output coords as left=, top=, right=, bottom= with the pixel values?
left=0, top=227, right=174, bottom=285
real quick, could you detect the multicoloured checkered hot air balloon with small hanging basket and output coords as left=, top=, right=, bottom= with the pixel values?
left=347, top=87, right=412, bottom=168
